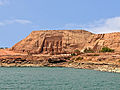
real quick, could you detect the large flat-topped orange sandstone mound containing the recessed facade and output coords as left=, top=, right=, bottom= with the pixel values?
left=11, top=30, right=94, bottom=54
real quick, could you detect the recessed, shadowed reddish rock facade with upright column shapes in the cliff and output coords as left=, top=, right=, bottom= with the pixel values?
left=40, top=36, right=62, bottom=54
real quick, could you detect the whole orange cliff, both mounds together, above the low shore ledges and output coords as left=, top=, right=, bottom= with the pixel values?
left=11, top=30, right=120, bottom=54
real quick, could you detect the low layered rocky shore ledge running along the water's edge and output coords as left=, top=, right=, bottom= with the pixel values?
left=0, top=53, right=120, bottom=73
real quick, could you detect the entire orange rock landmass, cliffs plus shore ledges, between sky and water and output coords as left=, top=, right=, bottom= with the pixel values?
left=0, top=30, right=120, bottom=72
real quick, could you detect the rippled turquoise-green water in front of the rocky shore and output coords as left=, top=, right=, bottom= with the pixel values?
left=0, top=67, right=120, bottom=90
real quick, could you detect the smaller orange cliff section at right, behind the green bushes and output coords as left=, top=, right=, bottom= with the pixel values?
left=84, top=32, right=120, bottom=51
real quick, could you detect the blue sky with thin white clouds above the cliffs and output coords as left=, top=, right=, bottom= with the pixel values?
left=0, top=0, right=120, bottom=47
